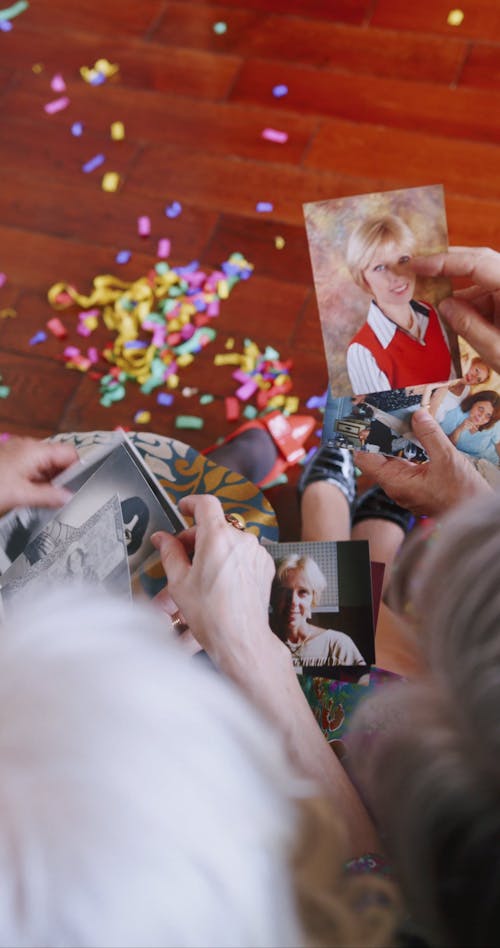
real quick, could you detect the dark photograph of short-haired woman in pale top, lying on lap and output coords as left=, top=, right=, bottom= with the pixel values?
left=265, top=540, right=375, bottom=677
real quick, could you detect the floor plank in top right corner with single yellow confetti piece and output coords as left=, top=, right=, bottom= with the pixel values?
left=370, top=0, right=500, bottom=42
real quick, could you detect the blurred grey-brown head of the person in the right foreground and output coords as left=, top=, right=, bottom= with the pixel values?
left=351, top=493, right=500, bottom=946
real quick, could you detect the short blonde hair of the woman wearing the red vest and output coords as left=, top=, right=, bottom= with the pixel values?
left=346, top=214, right=416, bottom=292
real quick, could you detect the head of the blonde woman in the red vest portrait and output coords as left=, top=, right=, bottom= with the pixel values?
left=346, top=214, right=416, bottom=309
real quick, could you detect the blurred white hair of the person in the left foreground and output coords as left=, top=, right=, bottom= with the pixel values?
left=0, top=588, right=303, bottom=948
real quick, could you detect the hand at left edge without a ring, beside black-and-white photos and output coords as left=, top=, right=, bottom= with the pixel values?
left=0, top=437, right=78, bottom=513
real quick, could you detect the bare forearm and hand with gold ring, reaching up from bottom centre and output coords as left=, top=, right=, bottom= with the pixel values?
left=153, top=495, right=377, bottom=854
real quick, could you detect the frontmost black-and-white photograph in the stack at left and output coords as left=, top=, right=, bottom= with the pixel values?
left=0, top=494, right=131, bottom=611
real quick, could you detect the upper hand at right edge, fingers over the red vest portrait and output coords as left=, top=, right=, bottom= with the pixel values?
left=413, top=247, right=500, bottom=372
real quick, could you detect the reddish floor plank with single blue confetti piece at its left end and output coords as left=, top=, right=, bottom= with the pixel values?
left=231, top=59, right=500, bottom=142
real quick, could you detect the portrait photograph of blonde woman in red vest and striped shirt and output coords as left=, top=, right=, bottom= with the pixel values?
left=303, top=185, right=460, bottom=395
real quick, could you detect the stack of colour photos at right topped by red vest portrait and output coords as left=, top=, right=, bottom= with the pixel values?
left=304, top=185, right=500, bottom=480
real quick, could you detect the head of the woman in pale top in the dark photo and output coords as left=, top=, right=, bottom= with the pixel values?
left=271, top=553, right=326, bottom=641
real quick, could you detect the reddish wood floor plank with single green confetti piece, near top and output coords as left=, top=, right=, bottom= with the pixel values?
left=155, top=0, right=468, bottom=83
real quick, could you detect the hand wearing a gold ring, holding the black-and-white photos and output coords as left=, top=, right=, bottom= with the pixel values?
left=152, top=494, right=281, bottom=670
